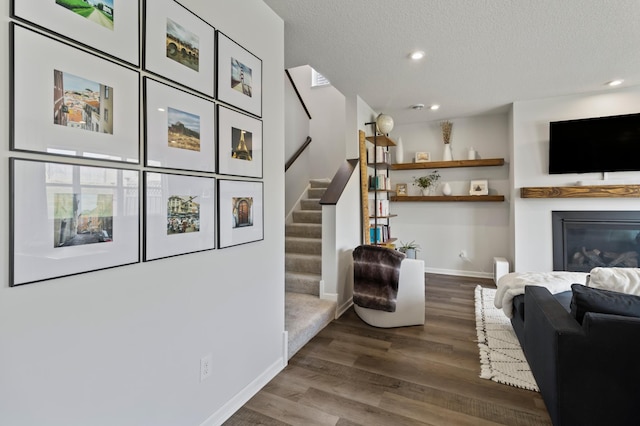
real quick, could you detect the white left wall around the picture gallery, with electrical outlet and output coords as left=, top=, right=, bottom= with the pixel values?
left=0, top=0, right=285, bottom=426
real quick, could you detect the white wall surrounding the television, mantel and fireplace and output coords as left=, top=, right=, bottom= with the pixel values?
left=511, top=86, right=640, bottom=271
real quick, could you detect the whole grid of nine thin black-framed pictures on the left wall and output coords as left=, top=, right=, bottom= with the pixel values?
left=8, top=0, right=264, bottom=286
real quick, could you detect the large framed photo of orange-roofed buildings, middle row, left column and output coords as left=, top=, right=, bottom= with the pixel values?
left=11, top=25, right=140, bottom=163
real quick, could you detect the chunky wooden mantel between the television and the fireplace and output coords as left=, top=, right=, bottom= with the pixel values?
left=520, top=185, right=640, bottom=198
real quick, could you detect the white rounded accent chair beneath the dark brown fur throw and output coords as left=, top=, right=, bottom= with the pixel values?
left=353, top=259, right=425, bottom=328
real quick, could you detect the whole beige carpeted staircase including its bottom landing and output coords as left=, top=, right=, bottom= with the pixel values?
left=285, top=179, right=336, bottom=358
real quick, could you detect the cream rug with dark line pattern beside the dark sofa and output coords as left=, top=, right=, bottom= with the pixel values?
left=475, top=286, right=539, bottom=392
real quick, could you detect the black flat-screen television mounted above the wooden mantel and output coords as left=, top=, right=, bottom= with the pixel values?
left=549, top=113, right=640, bottom=174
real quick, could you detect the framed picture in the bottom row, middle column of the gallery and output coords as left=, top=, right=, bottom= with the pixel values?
left=144, top=172, right=216, bottom=261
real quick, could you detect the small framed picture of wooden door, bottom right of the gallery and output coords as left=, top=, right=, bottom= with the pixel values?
left=218, top=180, right=264, bottom=248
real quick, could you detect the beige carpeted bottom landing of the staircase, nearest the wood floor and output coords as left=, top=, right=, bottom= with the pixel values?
left=284, top=292, right=336, bottom=359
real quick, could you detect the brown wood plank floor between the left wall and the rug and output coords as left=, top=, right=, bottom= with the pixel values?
left=225, top=274, right=551, bottom=426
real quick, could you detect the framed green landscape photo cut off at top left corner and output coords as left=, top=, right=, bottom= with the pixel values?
left=11, top=0, right=140, bottom=65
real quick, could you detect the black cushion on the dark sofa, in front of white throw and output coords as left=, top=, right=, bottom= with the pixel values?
left=571, top=284, right=640, bottom=324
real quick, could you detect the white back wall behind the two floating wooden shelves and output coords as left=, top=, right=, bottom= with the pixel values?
left=390, top=114, right=510, bottom=276
